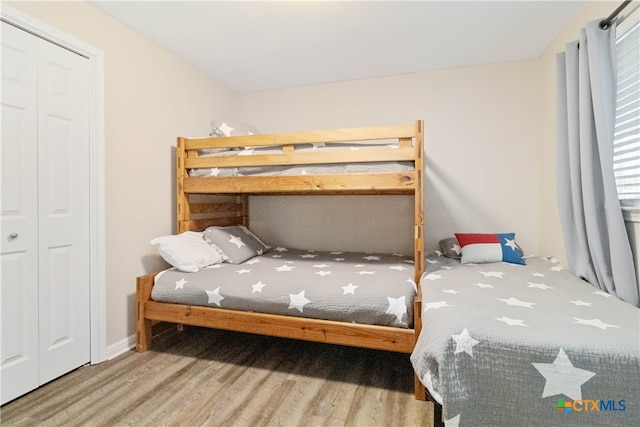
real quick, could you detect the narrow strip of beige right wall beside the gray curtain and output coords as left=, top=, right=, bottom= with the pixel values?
left=538, top=1, right=618, bottom=266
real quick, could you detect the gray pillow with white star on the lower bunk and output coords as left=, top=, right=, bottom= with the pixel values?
left=204, top=225, right=271, bottom=264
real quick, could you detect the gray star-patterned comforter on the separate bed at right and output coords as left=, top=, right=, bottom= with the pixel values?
left=411, top=256, right=640, bottom=427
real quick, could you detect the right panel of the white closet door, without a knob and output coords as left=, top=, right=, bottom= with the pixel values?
left=38, top=27, right=91, bottom=383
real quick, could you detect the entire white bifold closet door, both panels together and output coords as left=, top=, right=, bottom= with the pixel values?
left=0, top=23, right=90, bottom=403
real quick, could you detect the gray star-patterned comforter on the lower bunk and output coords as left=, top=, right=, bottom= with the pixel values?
left=151, top=248, right=416, bottom=328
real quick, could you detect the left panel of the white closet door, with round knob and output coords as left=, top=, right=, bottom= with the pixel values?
left=0, top=23, right=39, bottom=403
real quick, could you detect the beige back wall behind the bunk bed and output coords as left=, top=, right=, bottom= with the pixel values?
left=237, top=61, right=541, bottom=253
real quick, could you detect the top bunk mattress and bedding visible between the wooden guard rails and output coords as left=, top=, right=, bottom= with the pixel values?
left=188, top=141, right=415, bottom=178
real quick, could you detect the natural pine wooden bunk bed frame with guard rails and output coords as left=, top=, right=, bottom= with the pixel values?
left=136, top=120, right=425, bottom=400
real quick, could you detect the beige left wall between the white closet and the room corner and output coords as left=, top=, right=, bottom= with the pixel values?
left=5, top=2, right=233, bottom=346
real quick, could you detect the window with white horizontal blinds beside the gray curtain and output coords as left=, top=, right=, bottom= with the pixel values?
left=613, top=22, right=640, bottom=207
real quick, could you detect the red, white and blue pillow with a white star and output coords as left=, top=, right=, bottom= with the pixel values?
left=455, top=233, right=525, bottom=264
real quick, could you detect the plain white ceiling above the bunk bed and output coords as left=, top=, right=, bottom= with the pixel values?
left=91, top=0, right=584, bottom=92
